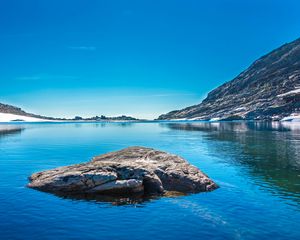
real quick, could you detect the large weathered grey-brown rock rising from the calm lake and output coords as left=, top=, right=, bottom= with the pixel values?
left=28, top=147, right=218, bottom=198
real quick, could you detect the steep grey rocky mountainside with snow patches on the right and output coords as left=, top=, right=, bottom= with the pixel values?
left=158, top=38, right=300, bottom=120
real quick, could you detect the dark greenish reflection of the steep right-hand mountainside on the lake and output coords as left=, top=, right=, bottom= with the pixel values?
left=162, top=122, right=300, bottom=203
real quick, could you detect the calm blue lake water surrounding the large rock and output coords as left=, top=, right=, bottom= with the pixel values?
left=0, top=122, right=300, bottom=240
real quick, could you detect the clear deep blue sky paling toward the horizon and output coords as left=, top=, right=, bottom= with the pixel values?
left=0, top=0, right=300, bottom=119
